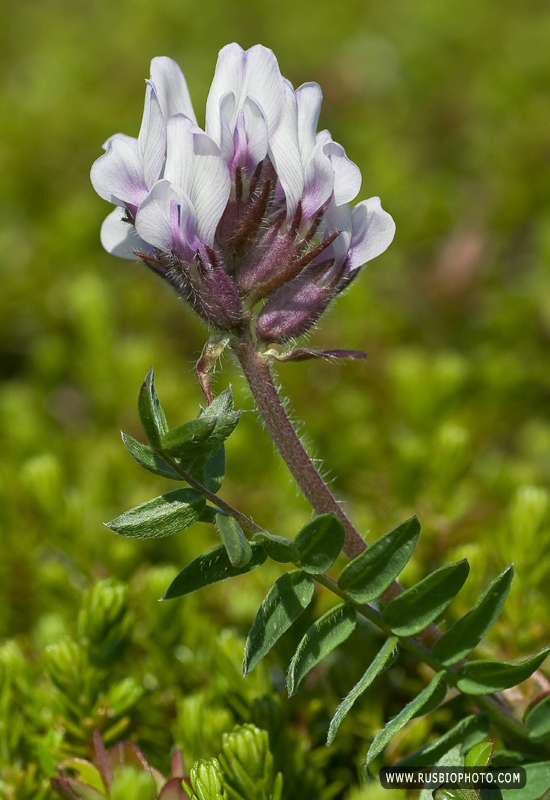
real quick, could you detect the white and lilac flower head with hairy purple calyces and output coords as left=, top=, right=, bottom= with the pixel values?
left=91, top=44, right=395, bottom=342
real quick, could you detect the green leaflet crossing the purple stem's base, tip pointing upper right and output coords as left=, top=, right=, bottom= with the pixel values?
left=338, top=517, right=420, bottom=603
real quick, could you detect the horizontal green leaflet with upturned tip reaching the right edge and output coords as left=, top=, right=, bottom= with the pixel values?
left=456, top=645, right=550, bottom=694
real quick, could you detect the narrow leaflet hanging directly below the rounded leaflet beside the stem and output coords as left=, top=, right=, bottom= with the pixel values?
left=287, top=603, right=357, bottom=695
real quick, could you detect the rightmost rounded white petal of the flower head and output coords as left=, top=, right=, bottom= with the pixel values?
left=347, top=197, right=395, bottom=272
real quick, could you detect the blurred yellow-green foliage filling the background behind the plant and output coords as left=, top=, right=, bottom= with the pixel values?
left=0, top=0, right=550, bottom=800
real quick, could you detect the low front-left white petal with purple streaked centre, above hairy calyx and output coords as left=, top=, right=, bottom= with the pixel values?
left=136, top=180, right=200, bottom=261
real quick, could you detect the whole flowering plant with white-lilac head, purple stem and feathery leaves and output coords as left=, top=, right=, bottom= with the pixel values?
left=91, top=44, right=550, bottom=788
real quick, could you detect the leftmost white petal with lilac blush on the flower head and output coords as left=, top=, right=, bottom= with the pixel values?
left=90, top=136, right=147, bottom=206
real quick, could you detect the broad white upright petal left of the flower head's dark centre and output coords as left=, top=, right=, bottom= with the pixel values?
left=164, top=114, right=231, bottom=246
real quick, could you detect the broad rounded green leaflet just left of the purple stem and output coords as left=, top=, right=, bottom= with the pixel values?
left=294, top=514, right=346, bottom=575
